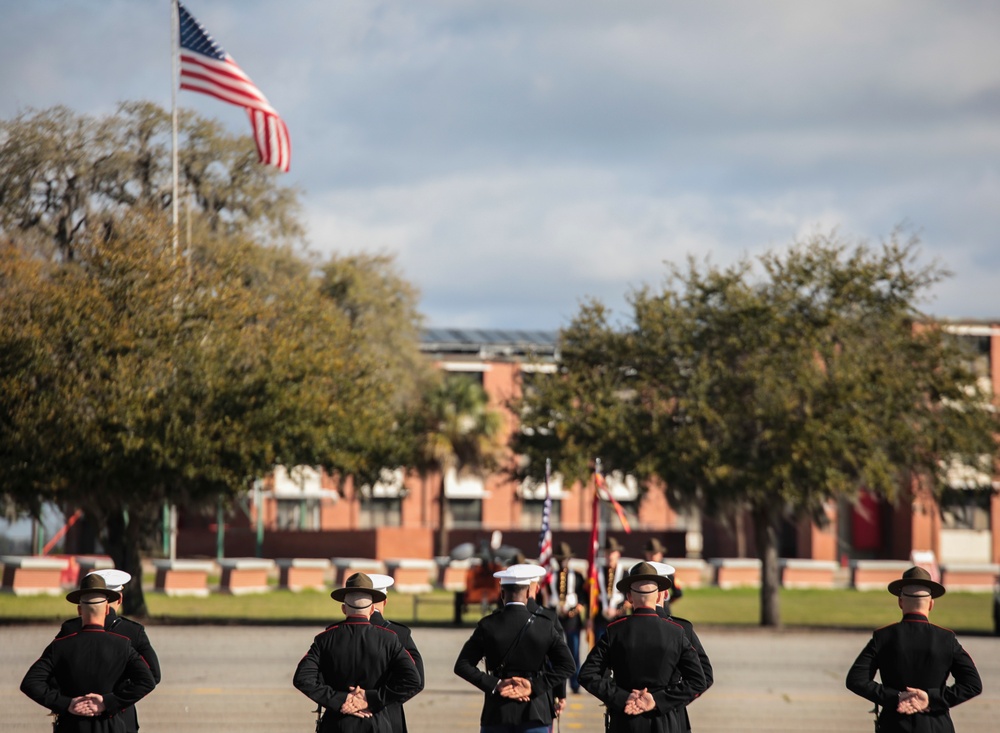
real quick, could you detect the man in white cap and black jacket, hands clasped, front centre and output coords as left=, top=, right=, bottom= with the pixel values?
left=455, top=568, right=575, bottom=733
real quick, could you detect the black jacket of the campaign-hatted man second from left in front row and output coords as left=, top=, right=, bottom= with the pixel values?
left=292, top=616, right=422, bottom=733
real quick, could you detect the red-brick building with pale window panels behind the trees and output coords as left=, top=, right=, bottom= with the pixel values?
left=178, top=322, right=1000, bottom=563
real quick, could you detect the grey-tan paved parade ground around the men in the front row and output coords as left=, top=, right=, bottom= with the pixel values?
left=0, top=626, right=1000, bottom=733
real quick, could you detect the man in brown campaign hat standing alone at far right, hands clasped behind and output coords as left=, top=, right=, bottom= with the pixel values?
left=847, top=567, right=983, bottom=733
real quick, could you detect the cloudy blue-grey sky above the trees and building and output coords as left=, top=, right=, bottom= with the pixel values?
left=0, top=0, right=1000, bottom=329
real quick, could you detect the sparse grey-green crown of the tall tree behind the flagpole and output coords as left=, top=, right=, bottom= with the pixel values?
left=0, top=102, right=302, bottom=260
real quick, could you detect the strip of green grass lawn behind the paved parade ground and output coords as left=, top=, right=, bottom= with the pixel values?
left=0, top=587, right=993, bottom=633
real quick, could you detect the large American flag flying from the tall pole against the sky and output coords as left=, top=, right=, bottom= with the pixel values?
left=177, top=3, right=292, bottom=173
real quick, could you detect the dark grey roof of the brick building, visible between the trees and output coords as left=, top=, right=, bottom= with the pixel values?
left=420, top=328, right=559, bottom=359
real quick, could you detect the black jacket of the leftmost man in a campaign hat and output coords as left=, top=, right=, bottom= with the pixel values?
left=21, top=625, right=156, bottom=733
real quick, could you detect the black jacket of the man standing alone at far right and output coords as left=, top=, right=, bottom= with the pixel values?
left=847, top=613, right=983, bottom=733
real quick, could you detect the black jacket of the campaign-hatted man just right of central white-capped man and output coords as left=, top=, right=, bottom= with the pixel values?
left=580, top=608, right=706, bottom=733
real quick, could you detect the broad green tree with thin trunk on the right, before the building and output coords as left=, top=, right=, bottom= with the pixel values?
left=518, top=236, right=997, bottom=625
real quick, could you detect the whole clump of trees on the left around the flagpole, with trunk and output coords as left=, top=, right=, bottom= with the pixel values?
left=0, top=104, right=419, bottom=612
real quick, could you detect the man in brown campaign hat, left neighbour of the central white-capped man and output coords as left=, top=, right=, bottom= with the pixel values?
left=292, top=573, right=421, bottom=733
